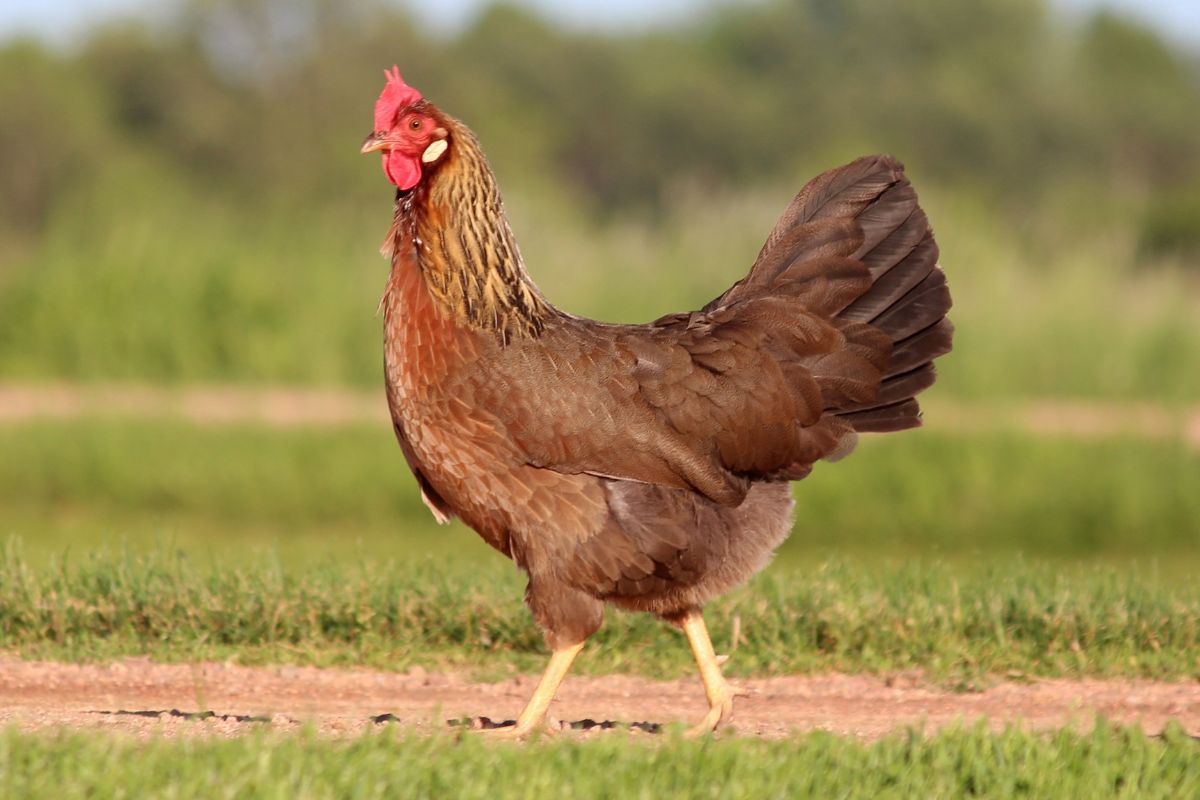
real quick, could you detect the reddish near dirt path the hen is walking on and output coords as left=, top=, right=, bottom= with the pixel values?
left=0, top=658, right=1200, bottom=738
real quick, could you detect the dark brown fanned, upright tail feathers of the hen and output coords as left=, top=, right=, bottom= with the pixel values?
left=709, top=156, right=954, bottom=432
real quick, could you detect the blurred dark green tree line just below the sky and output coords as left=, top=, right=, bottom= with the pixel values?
left=0, top=0, right=1200, bottom=221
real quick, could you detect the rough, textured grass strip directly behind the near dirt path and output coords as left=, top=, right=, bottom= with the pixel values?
left=0, top=545, right=1200, bottom=685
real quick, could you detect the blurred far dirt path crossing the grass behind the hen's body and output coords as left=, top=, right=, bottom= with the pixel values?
left=0, top=384, right=1200, bottom=450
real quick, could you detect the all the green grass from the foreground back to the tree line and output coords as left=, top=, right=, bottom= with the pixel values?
left=0, top=160, right=1200, bottom=798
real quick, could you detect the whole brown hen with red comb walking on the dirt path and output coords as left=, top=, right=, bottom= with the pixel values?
left=362, top=68, right=953, bottom=735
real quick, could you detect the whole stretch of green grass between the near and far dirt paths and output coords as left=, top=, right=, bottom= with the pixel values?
left=0, top=410, right=1200, bottom=680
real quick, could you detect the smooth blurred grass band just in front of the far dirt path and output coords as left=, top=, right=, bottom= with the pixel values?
left=0, top=419, right=1200, bottom=568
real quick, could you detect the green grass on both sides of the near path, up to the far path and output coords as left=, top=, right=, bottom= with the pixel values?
left=0, top=419, right=1200, bottom=798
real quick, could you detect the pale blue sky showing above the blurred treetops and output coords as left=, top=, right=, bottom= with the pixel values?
left=0, top=0, right=1200, bottom=47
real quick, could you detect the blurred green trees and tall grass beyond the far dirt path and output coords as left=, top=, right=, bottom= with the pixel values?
left=0, top=0, right=1200, bottom=388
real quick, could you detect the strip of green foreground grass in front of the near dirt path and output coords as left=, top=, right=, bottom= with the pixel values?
left=0, top=721, right=1200, bottom=800
